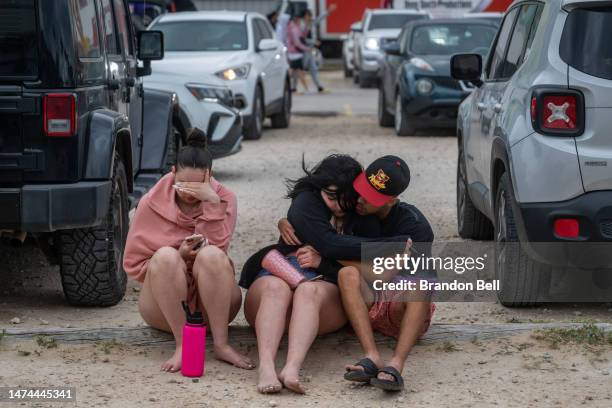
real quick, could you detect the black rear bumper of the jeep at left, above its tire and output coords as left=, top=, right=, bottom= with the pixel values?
left=0, top=180, right=111, bottom=232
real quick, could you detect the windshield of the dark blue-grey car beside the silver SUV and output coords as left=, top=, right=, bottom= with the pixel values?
left=410, top=24, right=497, bottom=55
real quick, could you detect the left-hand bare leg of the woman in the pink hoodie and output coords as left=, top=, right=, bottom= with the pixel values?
left=138, top=247, right=187, bottom=372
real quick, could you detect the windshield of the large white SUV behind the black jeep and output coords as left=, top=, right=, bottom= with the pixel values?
left=153, top=20, right=248, bottom=51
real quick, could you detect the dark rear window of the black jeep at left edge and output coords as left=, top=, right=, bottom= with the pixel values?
left=0, top=0, right=38, bottom=78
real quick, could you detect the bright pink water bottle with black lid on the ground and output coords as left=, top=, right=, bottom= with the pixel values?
left=181, top=302, right=206, bottom=377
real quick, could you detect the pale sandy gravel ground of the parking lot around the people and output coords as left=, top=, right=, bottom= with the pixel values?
left=0, top=72, right=612, bottom=407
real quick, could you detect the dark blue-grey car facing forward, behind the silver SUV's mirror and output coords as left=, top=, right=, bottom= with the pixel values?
left=378, top=19, right=497, bottom=136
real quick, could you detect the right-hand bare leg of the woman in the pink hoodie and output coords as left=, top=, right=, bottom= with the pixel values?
left=193, top=246, right=255, bottom=370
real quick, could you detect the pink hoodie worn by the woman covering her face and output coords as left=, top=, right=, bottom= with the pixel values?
left=123, top=173, right=237, bottom=282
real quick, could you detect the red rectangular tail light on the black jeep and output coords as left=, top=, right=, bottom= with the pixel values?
left=44, top=93, right=76, bottom=137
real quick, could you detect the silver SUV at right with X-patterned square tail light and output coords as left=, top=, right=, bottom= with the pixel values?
left=452, top=0, right=612, bottom=306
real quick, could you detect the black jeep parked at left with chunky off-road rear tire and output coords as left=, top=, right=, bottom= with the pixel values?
left=0, top=0, right=178, bottom=306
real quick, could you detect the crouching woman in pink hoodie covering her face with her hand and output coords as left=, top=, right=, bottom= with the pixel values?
left=123, top=129, right=254, bottom=372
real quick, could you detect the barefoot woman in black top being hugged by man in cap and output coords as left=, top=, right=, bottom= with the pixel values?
left=240, top=155, right=406, bottom=394
